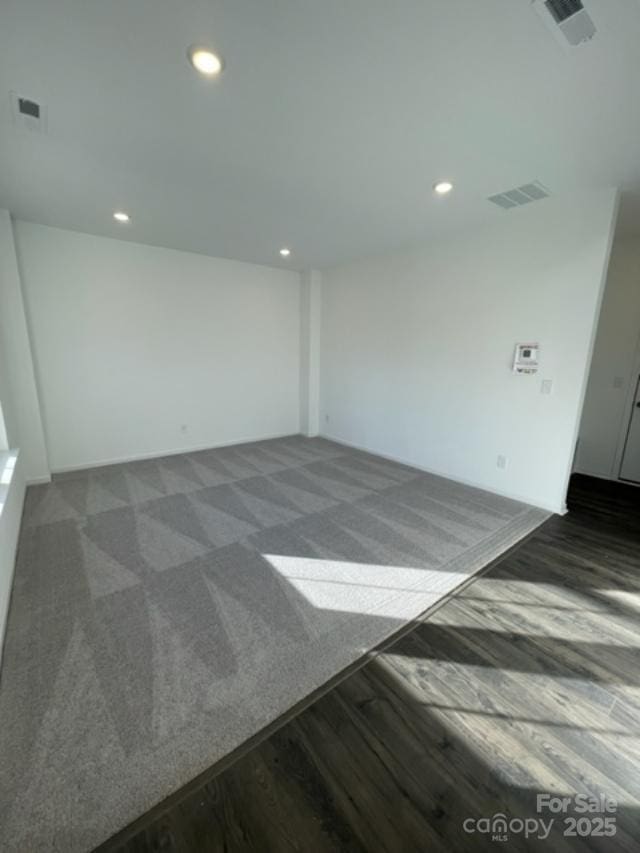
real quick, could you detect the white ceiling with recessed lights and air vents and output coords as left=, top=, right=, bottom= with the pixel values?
left=0, top=0, right=640, bottom=268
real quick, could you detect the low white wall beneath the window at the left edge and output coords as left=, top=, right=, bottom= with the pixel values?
left=0, top=452, right=25, bottom=659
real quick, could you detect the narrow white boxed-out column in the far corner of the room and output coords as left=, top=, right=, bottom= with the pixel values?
left=300, top=270, right=322, bottom=436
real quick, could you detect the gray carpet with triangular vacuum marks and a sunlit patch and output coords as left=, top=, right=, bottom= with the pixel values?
left=0, top=436, right=547, bottom=853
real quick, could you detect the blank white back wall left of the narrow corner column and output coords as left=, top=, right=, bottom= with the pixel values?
left=15, top=222, right=300, bottom=471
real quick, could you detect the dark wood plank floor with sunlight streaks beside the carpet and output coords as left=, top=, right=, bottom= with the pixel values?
left=103, top=477, right=640, bottom=853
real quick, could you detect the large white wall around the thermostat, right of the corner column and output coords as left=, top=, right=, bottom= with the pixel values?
left=321, top=191, right=617, bottom=512
